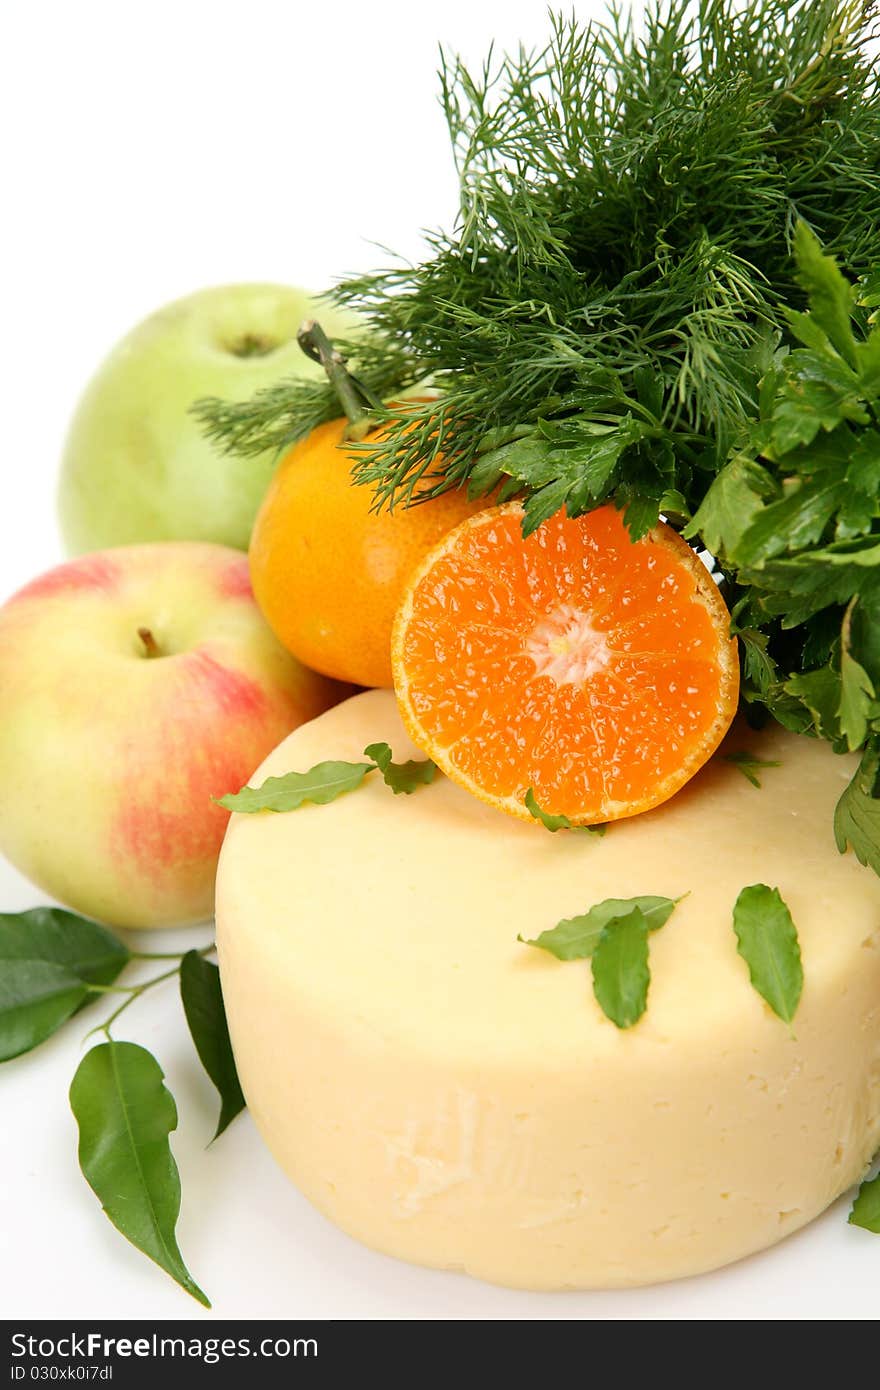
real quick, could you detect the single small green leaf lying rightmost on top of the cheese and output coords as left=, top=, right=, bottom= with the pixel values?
left=734, top=883, right=804, bottom=1023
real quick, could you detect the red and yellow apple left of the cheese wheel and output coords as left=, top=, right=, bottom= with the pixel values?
left=0, top=542, right=348, bottom=927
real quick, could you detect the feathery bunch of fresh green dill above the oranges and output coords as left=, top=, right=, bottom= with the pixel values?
left=197, top=0, right=880, bottom=535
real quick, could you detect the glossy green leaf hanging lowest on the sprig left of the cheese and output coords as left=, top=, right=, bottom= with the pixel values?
left=70, top=1040, right=210, bottom=1308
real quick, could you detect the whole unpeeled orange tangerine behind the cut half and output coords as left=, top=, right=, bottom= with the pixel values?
left=250, top=420, right=487, bottom=685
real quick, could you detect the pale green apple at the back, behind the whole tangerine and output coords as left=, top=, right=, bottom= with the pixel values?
left=58, top=285, right=352, bottom=555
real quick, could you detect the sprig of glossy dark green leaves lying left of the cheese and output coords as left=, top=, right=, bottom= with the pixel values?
left=0, top=908, right=245, bottom=1308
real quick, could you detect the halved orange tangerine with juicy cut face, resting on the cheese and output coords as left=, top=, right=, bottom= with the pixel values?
left=392, top=502, right=740, bottom=824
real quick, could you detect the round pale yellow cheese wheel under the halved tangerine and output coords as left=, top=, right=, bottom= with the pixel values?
left=217, top=691, right=880, bottom=1289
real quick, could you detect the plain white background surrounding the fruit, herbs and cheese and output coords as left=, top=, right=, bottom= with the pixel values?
left=0, top=0, right=880, bottom=1319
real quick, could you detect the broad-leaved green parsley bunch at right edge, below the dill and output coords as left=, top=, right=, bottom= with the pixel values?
left=685, top=232, right=880, bottom=872
